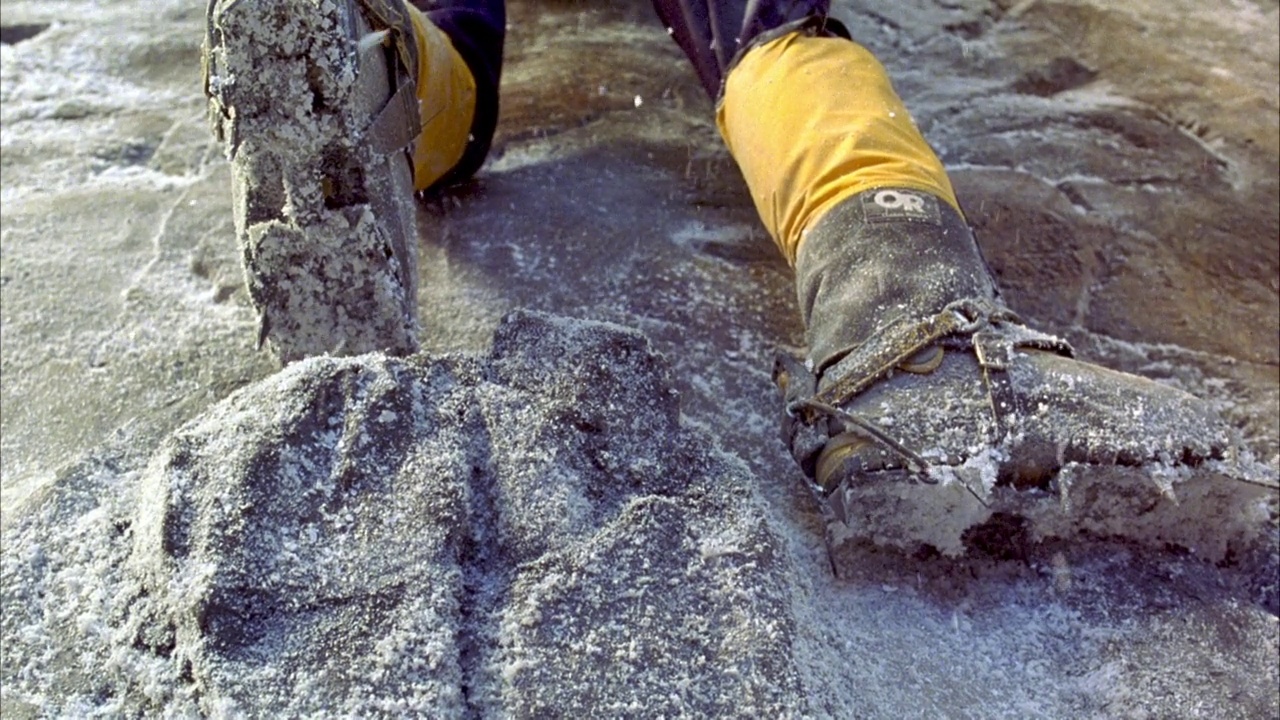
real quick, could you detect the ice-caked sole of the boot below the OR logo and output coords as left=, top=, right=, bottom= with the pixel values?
left=819, top=460, right=1276, bottom=562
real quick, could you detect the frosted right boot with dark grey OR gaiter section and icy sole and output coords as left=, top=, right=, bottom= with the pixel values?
left=776, top=188, right=1262, bottom=556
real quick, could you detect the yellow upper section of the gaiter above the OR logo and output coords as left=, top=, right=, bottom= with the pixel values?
left=716, top=33, right=960, bottom=265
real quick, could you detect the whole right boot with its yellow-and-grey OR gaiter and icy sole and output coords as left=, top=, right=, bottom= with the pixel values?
left=717, top=18, right=1267, bottom=557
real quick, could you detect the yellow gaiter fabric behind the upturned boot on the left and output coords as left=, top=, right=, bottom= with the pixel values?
left=406, top=4, right=476, bottom=190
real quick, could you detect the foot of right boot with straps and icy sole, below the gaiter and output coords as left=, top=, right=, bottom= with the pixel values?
left=774, top=301, right=1280, bottom=569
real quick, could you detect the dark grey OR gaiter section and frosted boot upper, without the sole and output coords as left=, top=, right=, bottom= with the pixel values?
left=792, top=188, right=1230, bottom=492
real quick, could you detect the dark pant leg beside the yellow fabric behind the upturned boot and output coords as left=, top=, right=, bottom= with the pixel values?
left=411, top=0, right=507, bottom=187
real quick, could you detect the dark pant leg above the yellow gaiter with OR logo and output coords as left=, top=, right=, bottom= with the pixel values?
left=653, top=0, right=849, bottom=99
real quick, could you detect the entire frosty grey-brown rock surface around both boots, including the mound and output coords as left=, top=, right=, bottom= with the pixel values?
left=0, top=0, right=1280, bottom=717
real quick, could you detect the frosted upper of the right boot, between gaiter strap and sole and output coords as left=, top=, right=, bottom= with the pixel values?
left=819, top=340, right=1230, bottom=488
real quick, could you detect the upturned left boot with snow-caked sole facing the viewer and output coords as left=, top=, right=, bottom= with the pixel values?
left=204, top=0, right=421, bottom=363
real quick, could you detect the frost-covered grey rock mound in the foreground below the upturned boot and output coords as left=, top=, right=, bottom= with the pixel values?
left=4, top=314, right=805, bottom=716
